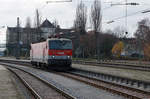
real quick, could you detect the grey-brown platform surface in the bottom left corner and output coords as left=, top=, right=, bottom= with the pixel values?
left=0, top=65, right=21, bottom=99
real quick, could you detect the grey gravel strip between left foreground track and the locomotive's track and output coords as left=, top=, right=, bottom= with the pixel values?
left=8, top=64, right=124, bottom=99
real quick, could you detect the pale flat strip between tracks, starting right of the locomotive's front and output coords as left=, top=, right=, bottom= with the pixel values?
left=72, top=64, right=150, bottom=81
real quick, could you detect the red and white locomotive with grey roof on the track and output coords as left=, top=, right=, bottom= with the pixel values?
left=30, top=38, right=72, bottom=69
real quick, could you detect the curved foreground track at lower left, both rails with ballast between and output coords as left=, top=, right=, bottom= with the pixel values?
left=5, top=64, right=76, bottom=99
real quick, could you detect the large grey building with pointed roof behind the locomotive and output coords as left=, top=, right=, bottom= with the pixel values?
left=6, top=19, right=74, bottom=56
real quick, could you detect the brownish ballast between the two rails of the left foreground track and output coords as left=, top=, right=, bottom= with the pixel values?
left=9, top=69, right=66, bottom=99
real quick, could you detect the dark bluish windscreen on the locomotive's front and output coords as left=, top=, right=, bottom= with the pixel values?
left=49, top=40, right=72, bottom=50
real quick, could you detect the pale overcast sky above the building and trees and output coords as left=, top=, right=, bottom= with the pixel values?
left=0, top=0, right=150, bottom=35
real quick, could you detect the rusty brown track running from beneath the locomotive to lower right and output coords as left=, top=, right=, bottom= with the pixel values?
left=50, top=72, right=150, bottom=99
